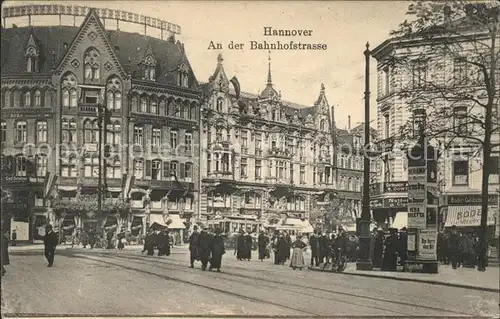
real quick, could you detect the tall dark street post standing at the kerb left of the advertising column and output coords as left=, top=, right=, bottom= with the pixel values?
left=356, top=43, right=373, bottom=270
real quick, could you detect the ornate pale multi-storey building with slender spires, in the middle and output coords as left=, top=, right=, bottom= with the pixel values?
left=200, top=55, right=370, bottom=232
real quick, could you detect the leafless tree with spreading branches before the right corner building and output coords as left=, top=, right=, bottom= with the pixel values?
left=390, top=0, right=500, bottom=270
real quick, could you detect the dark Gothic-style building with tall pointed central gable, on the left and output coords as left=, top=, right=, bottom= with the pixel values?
left=1, top=6, right=200, bottom=240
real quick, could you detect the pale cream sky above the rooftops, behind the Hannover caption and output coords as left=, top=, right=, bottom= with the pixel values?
left=3, top=1, right=408, bottom=128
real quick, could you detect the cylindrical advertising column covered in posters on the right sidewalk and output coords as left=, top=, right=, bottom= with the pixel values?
left=405, top=140, right=438, bottom=273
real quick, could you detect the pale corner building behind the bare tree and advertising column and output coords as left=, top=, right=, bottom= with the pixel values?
left=371, top=4, right=499, bottom=227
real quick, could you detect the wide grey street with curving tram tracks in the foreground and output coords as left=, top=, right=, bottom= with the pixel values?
left=2, top=248, right=499, bottom=317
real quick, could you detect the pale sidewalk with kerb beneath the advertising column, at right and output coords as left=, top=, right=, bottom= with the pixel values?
left=309, top=263, right=500, bottom=292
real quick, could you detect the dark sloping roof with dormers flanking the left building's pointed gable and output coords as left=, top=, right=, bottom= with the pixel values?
left=1, top=26, right=198, bottom=89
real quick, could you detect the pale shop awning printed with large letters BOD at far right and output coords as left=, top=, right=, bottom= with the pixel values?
left=444, top=205, right=498, bottom=227
